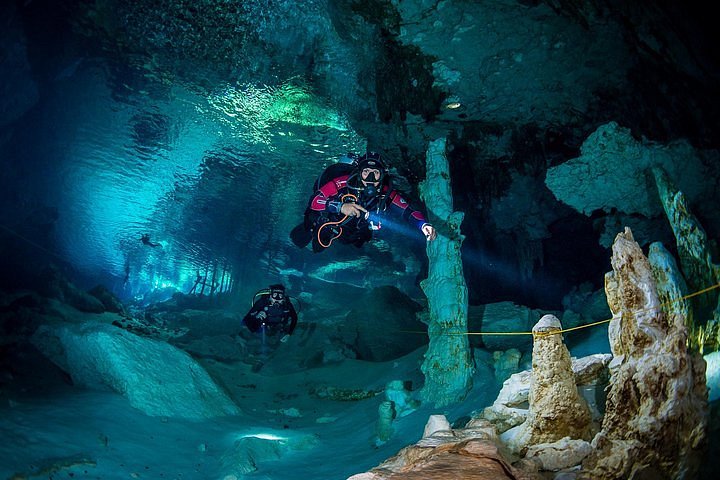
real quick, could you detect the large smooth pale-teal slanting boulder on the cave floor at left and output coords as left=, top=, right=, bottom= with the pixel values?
left=32, top=322, right=239, bottom=418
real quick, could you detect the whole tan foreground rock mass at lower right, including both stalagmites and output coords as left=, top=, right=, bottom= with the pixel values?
left=352, top=229, right=708, bottom=480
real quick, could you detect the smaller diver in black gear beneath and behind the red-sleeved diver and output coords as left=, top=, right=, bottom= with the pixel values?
left=243, top=284, right=297, bottom=343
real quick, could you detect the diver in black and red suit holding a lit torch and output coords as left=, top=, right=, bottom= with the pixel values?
left=290, top=152, right=436, bottom=253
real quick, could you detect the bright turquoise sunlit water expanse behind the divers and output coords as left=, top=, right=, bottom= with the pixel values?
left=0, top=61, right=372, bottom=299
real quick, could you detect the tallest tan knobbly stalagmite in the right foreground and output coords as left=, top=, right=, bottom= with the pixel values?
left=579, top=229, right=707, bottom=480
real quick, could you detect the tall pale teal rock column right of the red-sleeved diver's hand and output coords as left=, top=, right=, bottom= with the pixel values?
left=420, top=138, right=473, bottom=407
